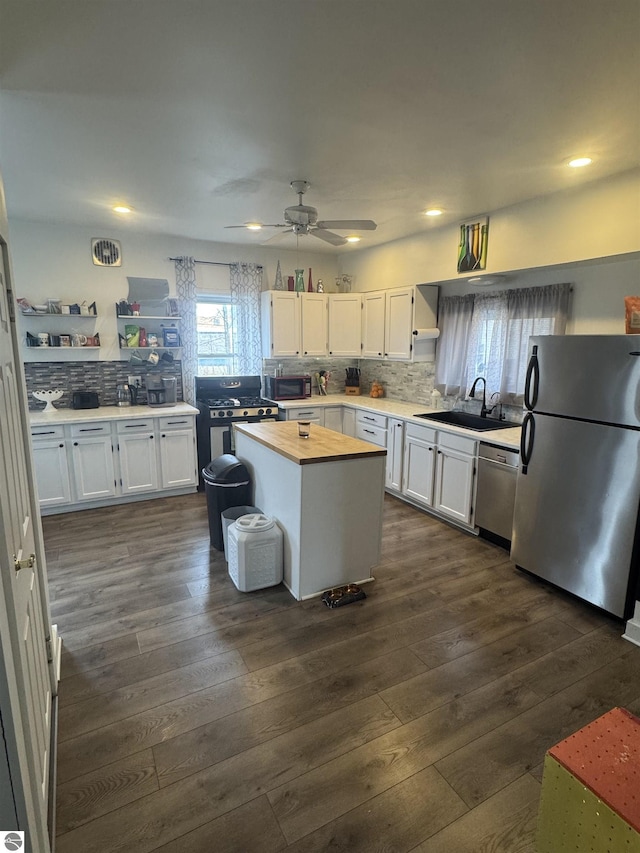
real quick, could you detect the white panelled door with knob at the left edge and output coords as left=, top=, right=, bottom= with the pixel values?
left=0, top=251, right=51, bottom=851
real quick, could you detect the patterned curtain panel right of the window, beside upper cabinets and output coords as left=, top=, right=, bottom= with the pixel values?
left=230, top=263, right=262, bottom=376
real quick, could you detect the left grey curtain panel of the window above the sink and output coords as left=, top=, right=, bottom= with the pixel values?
left=435, top=294, right=475, bottom=396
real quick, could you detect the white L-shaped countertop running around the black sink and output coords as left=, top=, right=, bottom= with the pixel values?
left=278, top=394, right=522, bottom=450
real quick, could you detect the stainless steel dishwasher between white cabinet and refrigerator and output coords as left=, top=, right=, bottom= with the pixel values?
left=475, top=441, right=518, bottom=542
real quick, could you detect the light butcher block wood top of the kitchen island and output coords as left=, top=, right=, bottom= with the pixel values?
left=235, top=421, right=387, bottom=465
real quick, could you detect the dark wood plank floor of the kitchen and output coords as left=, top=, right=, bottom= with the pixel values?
left=44, top=495, right=640, bottom=853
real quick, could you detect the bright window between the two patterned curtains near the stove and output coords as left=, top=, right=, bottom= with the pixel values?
left=196, top=294, right=239, bottom=376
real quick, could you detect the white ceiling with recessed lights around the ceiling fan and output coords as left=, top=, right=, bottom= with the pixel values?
left=0, top=0, right=640, bottom=252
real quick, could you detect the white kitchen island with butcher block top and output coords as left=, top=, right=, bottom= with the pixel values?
left=234, top=421, right=387, bottom=601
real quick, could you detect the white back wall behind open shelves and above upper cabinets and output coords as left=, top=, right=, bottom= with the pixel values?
left=9, top=218, right=338, bottom=361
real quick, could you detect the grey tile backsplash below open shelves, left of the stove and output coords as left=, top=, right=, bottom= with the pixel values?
left=24, top=360, right=184, bottom=412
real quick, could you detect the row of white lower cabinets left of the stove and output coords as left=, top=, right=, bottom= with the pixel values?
left=31, top=414, right=198, bottom=515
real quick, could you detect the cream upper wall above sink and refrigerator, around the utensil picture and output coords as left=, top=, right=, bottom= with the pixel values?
left=340, top=169, right=640, bottom=291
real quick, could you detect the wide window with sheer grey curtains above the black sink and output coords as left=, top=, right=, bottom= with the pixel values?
left=436, top=284, right=571, bottom=405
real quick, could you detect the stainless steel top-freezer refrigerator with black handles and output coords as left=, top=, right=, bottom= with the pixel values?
left=511, top=335, right=640, bottom=618
